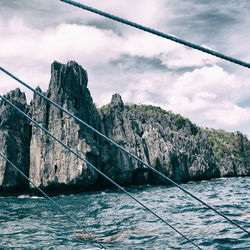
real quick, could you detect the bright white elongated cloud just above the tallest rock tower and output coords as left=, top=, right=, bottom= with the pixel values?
left=0, top=18, right=119, bottom=63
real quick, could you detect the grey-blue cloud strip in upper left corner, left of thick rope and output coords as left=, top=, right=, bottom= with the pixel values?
left=0, top=0, right=126, bottom=34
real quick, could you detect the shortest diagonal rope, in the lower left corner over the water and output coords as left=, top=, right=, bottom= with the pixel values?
left=0, top=152, right=105, bottom=249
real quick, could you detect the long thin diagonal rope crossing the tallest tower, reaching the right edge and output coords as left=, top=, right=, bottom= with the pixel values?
left=0, top=67, right=250, bottom=234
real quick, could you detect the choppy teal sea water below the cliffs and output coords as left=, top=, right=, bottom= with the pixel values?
left=0, top=177, right=250, bottom=249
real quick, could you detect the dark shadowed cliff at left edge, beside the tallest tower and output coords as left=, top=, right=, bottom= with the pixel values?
left=0, top=89, right=30, bottom=192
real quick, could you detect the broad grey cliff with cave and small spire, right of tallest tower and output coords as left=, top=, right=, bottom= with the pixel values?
left=101, top=95, right=220, bottom=184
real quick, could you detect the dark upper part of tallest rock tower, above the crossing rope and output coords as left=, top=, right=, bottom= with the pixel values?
left=47, top=61, right=98, bottom=126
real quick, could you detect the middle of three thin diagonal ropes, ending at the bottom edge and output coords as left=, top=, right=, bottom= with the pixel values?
left=0, top=95, right=201, bottom=249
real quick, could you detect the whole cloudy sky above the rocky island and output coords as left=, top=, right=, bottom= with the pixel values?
left=0, top=0, right=250, bottom=138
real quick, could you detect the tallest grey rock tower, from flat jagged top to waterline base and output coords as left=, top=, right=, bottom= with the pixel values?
left=29, top=62, right=100, bottom=188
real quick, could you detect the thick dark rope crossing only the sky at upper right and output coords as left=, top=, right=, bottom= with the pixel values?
left=60, top=0, right=250, bottom=68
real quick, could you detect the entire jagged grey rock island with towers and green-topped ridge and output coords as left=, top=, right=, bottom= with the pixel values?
left=0, top=62, right=250, bottom=195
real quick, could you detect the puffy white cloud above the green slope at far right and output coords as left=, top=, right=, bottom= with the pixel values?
left=141, top=66, right=250, bottom=133
